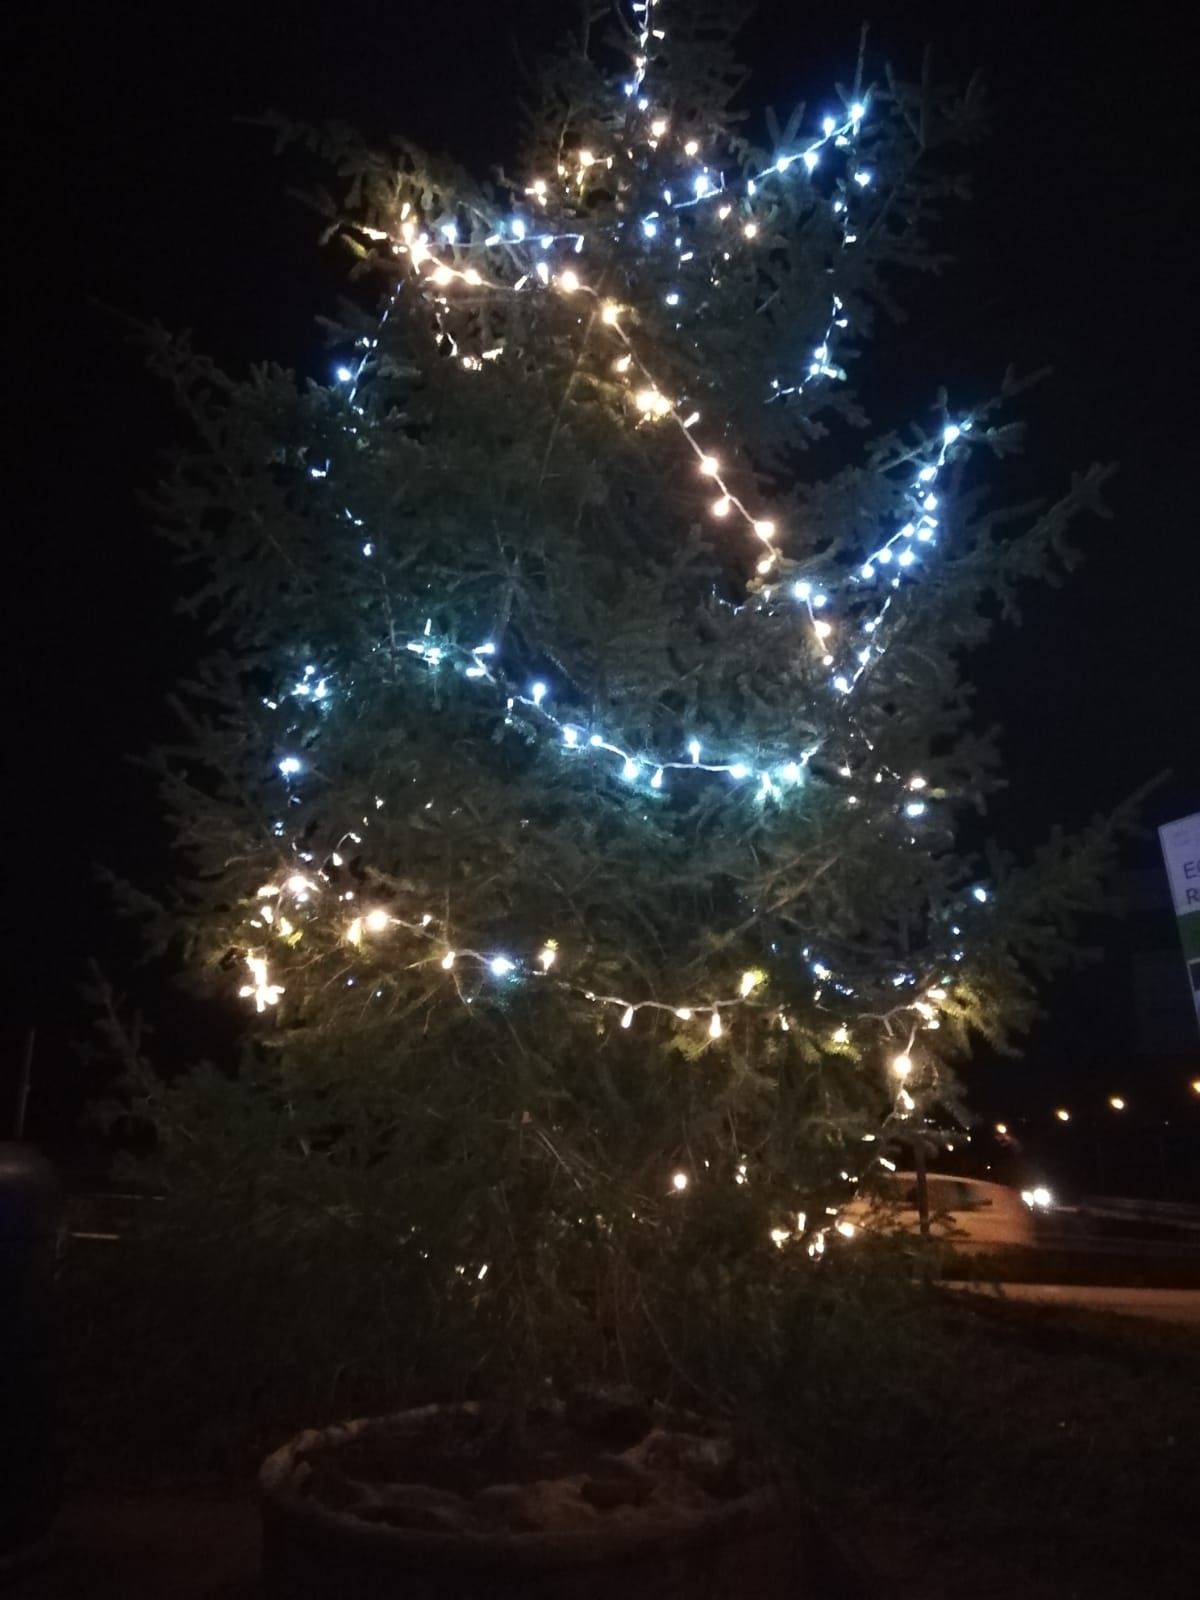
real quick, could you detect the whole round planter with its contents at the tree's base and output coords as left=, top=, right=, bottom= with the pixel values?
left=259, top=1397, right=824, bottom=1600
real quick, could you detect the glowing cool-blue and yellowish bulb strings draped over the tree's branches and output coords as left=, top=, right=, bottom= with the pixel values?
left=232, top=0, right=987, bottom=1209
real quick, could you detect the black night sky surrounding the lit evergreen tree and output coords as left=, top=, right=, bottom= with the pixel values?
left=9, top=0, right=1200, bottom=1160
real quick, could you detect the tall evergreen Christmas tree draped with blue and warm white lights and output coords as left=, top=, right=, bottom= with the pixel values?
left=136, top=0, right=1126, bottom=1395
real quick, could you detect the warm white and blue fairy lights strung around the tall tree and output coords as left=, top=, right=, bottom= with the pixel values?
left=227, top=0, right=989, bottom=1248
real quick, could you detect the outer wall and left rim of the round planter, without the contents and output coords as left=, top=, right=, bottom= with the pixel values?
left=259, top=1406, right=834, bottom=1600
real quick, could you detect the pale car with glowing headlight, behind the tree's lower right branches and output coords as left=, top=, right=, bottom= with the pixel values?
left=837, top=1173, right=1051, bottom=1250
